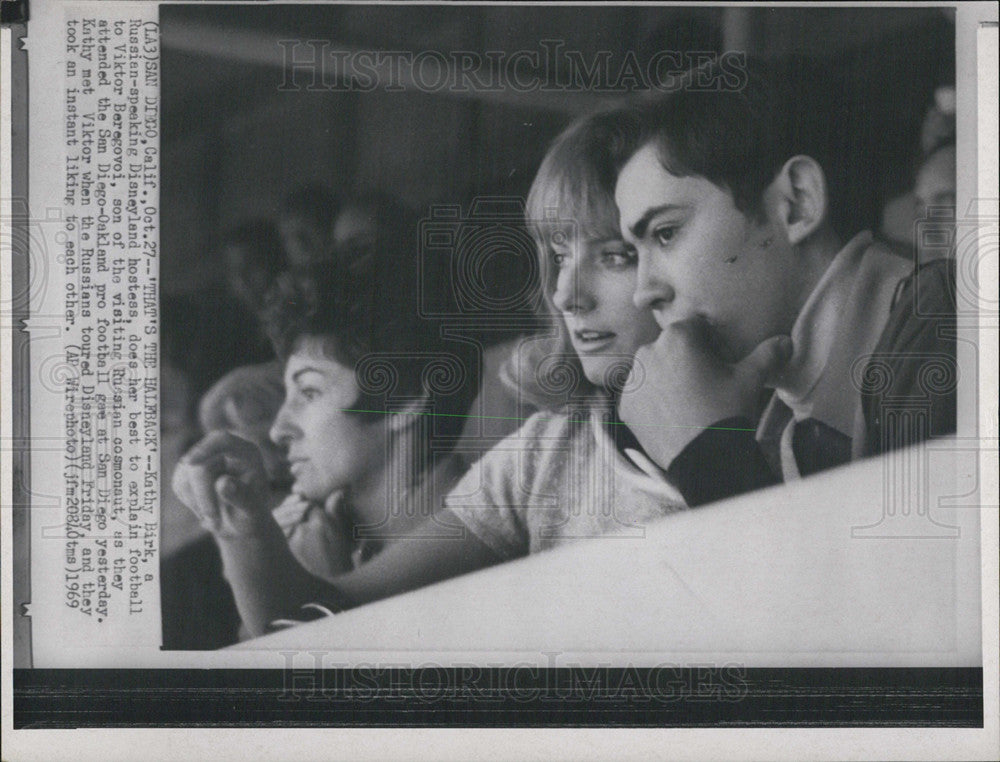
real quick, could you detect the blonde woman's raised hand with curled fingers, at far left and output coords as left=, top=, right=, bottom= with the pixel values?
left=173, top=431, right=274, bottom=538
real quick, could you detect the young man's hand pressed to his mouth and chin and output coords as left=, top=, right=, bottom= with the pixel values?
left=618, top=319, right=792, bottom=469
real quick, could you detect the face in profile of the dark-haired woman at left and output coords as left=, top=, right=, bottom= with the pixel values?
left=271, top=336, right=388, bottom=501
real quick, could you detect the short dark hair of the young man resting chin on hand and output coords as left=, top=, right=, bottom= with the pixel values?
left=612, top=57, right=870, bottom=237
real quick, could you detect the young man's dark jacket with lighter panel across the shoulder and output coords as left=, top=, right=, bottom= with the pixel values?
left=667, top=233, right=958, bottom=506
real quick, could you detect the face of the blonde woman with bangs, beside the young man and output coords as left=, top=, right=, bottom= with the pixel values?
left=549, top=234, right=660, bottom=389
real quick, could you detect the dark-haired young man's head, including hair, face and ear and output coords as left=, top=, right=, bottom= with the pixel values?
left=615, top=59, right=853, bottom=362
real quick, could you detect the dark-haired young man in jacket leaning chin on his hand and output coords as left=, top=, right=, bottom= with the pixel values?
left=615, top=63, right=957, bottom=505
